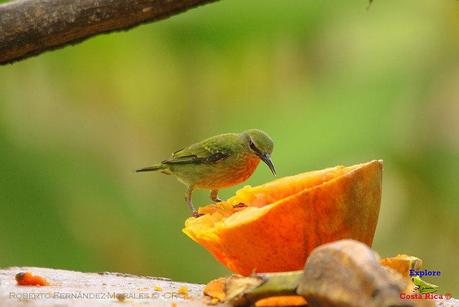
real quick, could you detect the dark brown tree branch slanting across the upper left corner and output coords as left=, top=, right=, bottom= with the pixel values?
left=0, top=0, right=216, bottom=64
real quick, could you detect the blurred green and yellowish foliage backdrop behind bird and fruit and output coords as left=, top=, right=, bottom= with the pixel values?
left=0, top=0, right=459, bottom=296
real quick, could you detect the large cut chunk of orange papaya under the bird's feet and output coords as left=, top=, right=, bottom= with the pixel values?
left=183, top=161, right=382, bottom=275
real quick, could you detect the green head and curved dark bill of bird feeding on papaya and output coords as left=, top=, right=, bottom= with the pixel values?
left=242, top=129, right=276, bottom=176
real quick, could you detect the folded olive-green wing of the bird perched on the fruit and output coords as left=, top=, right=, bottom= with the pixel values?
left=162, top=141, right=232, bottom=164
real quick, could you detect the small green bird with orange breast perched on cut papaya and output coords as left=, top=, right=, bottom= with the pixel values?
left=136, top=129, right=276, bottom=216
